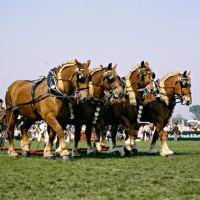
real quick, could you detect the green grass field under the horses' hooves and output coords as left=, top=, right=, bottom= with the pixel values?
left=0, top=141, right=200, bottom=200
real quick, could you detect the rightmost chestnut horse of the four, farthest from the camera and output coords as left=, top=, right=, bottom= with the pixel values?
left=135, top=71, right=192, bottom=157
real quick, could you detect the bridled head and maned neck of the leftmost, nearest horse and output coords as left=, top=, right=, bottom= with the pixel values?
left=57, top=59, right=90, bottom=100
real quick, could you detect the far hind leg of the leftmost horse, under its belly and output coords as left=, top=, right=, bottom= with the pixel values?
left=20, top=119, right=35, bottom=157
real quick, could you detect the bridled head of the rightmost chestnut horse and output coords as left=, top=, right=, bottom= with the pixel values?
left=175, top=71, right=192, bottom=106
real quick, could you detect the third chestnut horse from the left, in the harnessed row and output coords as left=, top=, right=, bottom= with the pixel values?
left=96, top=61, right=155, bottom=155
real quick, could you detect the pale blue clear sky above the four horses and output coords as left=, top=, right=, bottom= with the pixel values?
left=0, top=0, right=200, bottom=119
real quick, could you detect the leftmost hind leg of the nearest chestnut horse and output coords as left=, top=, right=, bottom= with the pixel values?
left=6, top=110, right=18, bottom=158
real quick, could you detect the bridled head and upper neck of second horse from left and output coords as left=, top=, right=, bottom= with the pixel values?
left=92, top=63, right=124, bottom=98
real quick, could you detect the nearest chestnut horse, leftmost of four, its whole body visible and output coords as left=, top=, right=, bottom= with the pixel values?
left=5, top=59, right=90, bottom=160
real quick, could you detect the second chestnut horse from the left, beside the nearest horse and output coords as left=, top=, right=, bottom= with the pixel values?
left=53, top=63, right=124, bottom=157
